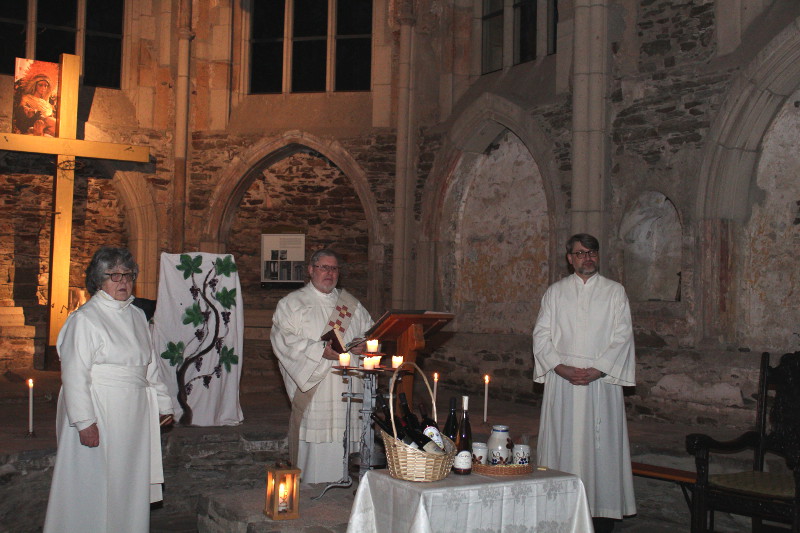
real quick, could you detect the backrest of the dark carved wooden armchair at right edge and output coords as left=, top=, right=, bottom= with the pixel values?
left=756, top=352, right=800, bottom=470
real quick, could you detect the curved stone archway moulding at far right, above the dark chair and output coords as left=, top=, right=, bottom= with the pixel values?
left=695, top=19, right=800, bottom=342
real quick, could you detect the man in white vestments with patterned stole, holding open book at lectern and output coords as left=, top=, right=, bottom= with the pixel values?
left=270, top=249, right=372, bottom=483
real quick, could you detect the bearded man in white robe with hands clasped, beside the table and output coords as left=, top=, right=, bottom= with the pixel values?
left=533, top=234, right=636, bottom=532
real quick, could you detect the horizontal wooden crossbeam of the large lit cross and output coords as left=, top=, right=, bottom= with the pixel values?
left=0, top=131, right=150, bottom=163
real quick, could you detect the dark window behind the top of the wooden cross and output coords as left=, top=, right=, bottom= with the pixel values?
left=0, top=0, right=125, bottom=89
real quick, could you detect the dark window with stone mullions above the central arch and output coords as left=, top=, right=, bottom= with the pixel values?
left=249, top=0, right=373, bottom=94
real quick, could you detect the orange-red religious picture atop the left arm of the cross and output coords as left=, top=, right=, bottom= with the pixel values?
left=11, top=57, right=60, bottom=137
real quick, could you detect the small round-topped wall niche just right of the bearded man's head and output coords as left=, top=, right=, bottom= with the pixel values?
left=620, top=191, right=682, bottom=302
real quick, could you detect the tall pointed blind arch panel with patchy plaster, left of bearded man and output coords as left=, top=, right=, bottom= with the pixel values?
left=440, top=130, right=550, bottom=334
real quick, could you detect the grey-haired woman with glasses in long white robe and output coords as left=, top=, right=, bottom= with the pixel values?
left=44, top=247, right=172, bottom=533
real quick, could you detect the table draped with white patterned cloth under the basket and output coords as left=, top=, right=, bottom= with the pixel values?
left=347, top=470, right=593, bottom=533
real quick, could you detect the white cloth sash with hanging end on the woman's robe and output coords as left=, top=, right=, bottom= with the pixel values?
left=92, top=364, right=164, bottom=502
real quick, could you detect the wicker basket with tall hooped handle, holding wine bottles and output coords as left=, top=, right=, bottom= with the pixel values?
left=381, top=362, right=456, bottom=482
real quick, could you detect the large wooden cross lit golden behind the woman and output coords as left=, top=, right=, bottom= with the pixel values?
left=0, top=54, right=150, bottom=360
